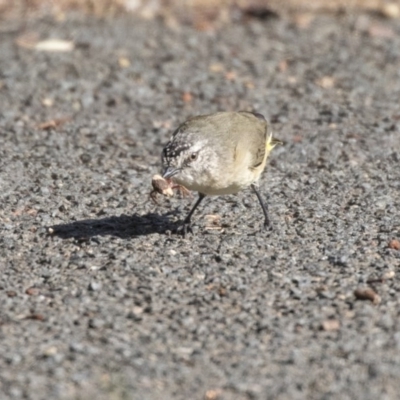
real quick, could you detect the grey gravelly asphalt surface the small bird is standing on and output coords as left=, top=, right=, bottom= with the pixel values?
left=0, top=8, right=400, bottom=400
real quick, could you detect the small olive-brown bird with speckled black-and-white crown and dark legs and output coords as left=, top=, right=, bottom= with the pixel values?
left=161, top=111, right=282, bottom=235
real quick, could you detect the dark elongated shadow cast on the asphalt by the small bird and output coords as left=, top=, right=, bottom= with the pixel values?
left=49, top=212, right=175, bottom=240
